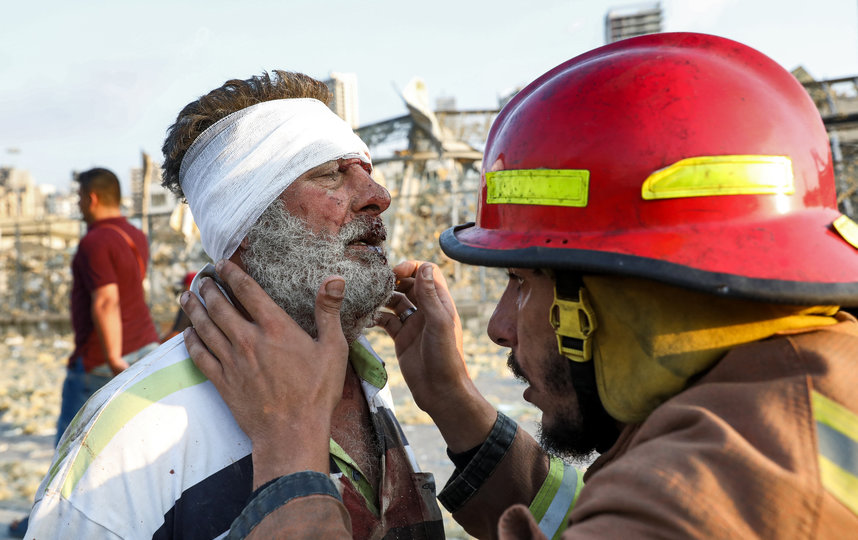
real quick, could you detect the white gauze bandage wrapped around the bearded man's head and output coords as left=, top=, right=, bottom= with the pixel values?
left=179, top=98, right=370, bottom=261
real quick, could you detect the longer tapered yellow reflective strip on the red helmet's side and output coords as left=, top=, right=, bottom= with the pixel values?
left=641, top=156, right=795, bottom=200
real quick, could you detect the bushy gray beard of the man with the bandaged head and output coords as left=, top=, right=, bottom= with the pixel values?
left=241, top=200, right=394, bottom=343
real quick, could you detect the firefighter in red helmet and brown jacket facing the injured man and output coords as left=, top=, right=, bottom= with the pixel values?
left=420, top=34, right=858, bottom=538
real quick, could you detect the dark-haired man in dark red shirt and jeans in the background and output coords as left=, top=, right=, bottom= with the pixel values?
left=57, top=168, right=158, bottom=442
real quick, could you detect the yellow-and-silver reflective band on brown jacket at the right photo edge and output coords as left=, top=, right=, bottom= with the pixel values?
left=811, top=392, right=858, bottom=514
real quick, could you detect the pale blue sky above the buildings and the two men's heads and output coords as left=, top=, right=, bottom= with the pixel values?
left=0, top=0, right=858, bottom=190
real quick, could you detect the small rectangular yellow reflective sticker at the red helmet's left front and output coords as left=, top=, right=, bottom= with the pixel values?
left=486, top=169, right=590, bottom=208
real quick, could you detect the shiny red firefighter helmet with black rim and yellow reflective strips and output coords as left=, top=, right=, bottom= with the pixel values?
left=441, top=33, right=858, bottom=305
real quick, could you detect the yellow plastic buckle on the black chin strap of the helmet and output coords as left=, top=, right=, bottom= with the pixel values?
left=550, top=275, right=597, bottom=362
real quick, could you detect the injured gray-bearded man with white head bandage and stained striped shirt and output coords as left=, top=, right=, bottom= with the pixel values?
left=26, top=70, right=444, bottom=540
